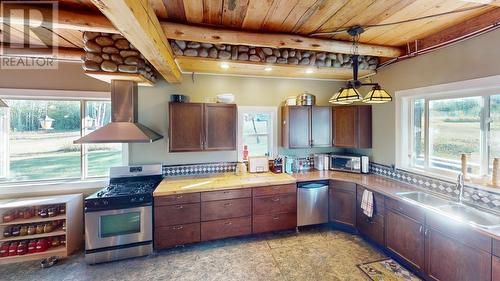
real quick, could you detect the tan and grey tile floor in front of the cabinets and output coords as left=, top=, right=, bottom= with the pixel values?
left=0, top=227, right=384, bottom=281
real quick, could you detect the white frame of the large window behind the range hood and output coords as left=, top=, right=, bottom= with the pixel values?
left=0, top=88, right=129, bottom=184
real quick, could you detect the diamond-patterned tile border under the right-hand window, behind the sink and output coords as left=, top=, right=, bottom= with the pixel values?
left=370, top=163, right=500, bottom=212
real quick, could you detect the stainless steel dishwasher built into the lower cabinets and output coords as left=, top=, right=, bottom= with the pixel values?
left=297, top=181, right=328, bottom=226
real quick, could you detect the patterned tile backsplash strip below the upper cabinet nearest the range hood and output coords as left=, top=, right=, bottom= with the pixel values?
left=163, top=162, right=236, bottom=177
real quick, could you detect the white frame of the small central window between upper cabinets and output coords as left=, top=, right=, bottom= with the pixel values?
left=236, top=106, right=278, bottom=162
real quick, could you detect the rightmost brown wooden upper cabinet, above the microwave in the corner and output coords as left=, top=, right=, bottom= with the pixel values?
left=333, top=105, right=372, bottom=148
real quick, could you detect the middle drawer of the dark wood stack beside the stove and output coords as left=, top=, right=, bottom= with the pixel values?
left=155, top=203, right=200, bottom=226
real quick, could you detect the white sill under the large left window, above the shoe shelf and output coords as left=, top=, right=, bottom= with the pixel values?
left=0, top=178, right=108, bottom=199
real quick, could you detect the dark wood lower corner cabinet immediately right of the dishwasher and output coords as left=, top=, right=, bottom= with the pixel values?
left=328, top=181, right=356, bottom=227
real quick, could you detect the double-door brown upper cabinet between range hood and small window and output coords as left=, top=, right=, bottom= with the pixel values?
left=169, top=103, right=237, bottom=152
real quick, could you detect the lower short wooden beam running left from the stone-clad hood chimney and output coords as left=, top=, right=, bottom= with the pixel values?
left=0, top=44, right=84, bottom=62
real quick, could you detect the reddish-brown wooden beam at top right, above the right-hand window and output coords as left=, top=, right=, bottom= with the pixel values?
left=407, top=8, right=500, bottom=53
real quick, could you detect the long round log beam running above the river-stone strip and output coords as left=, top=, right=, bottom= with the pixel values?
left=161, top=22, right=403, bottom=57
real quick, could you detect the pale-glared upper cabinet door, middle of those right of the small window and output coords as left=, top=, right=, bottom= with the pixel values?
left=311, top=106, right=332, bottom=147
